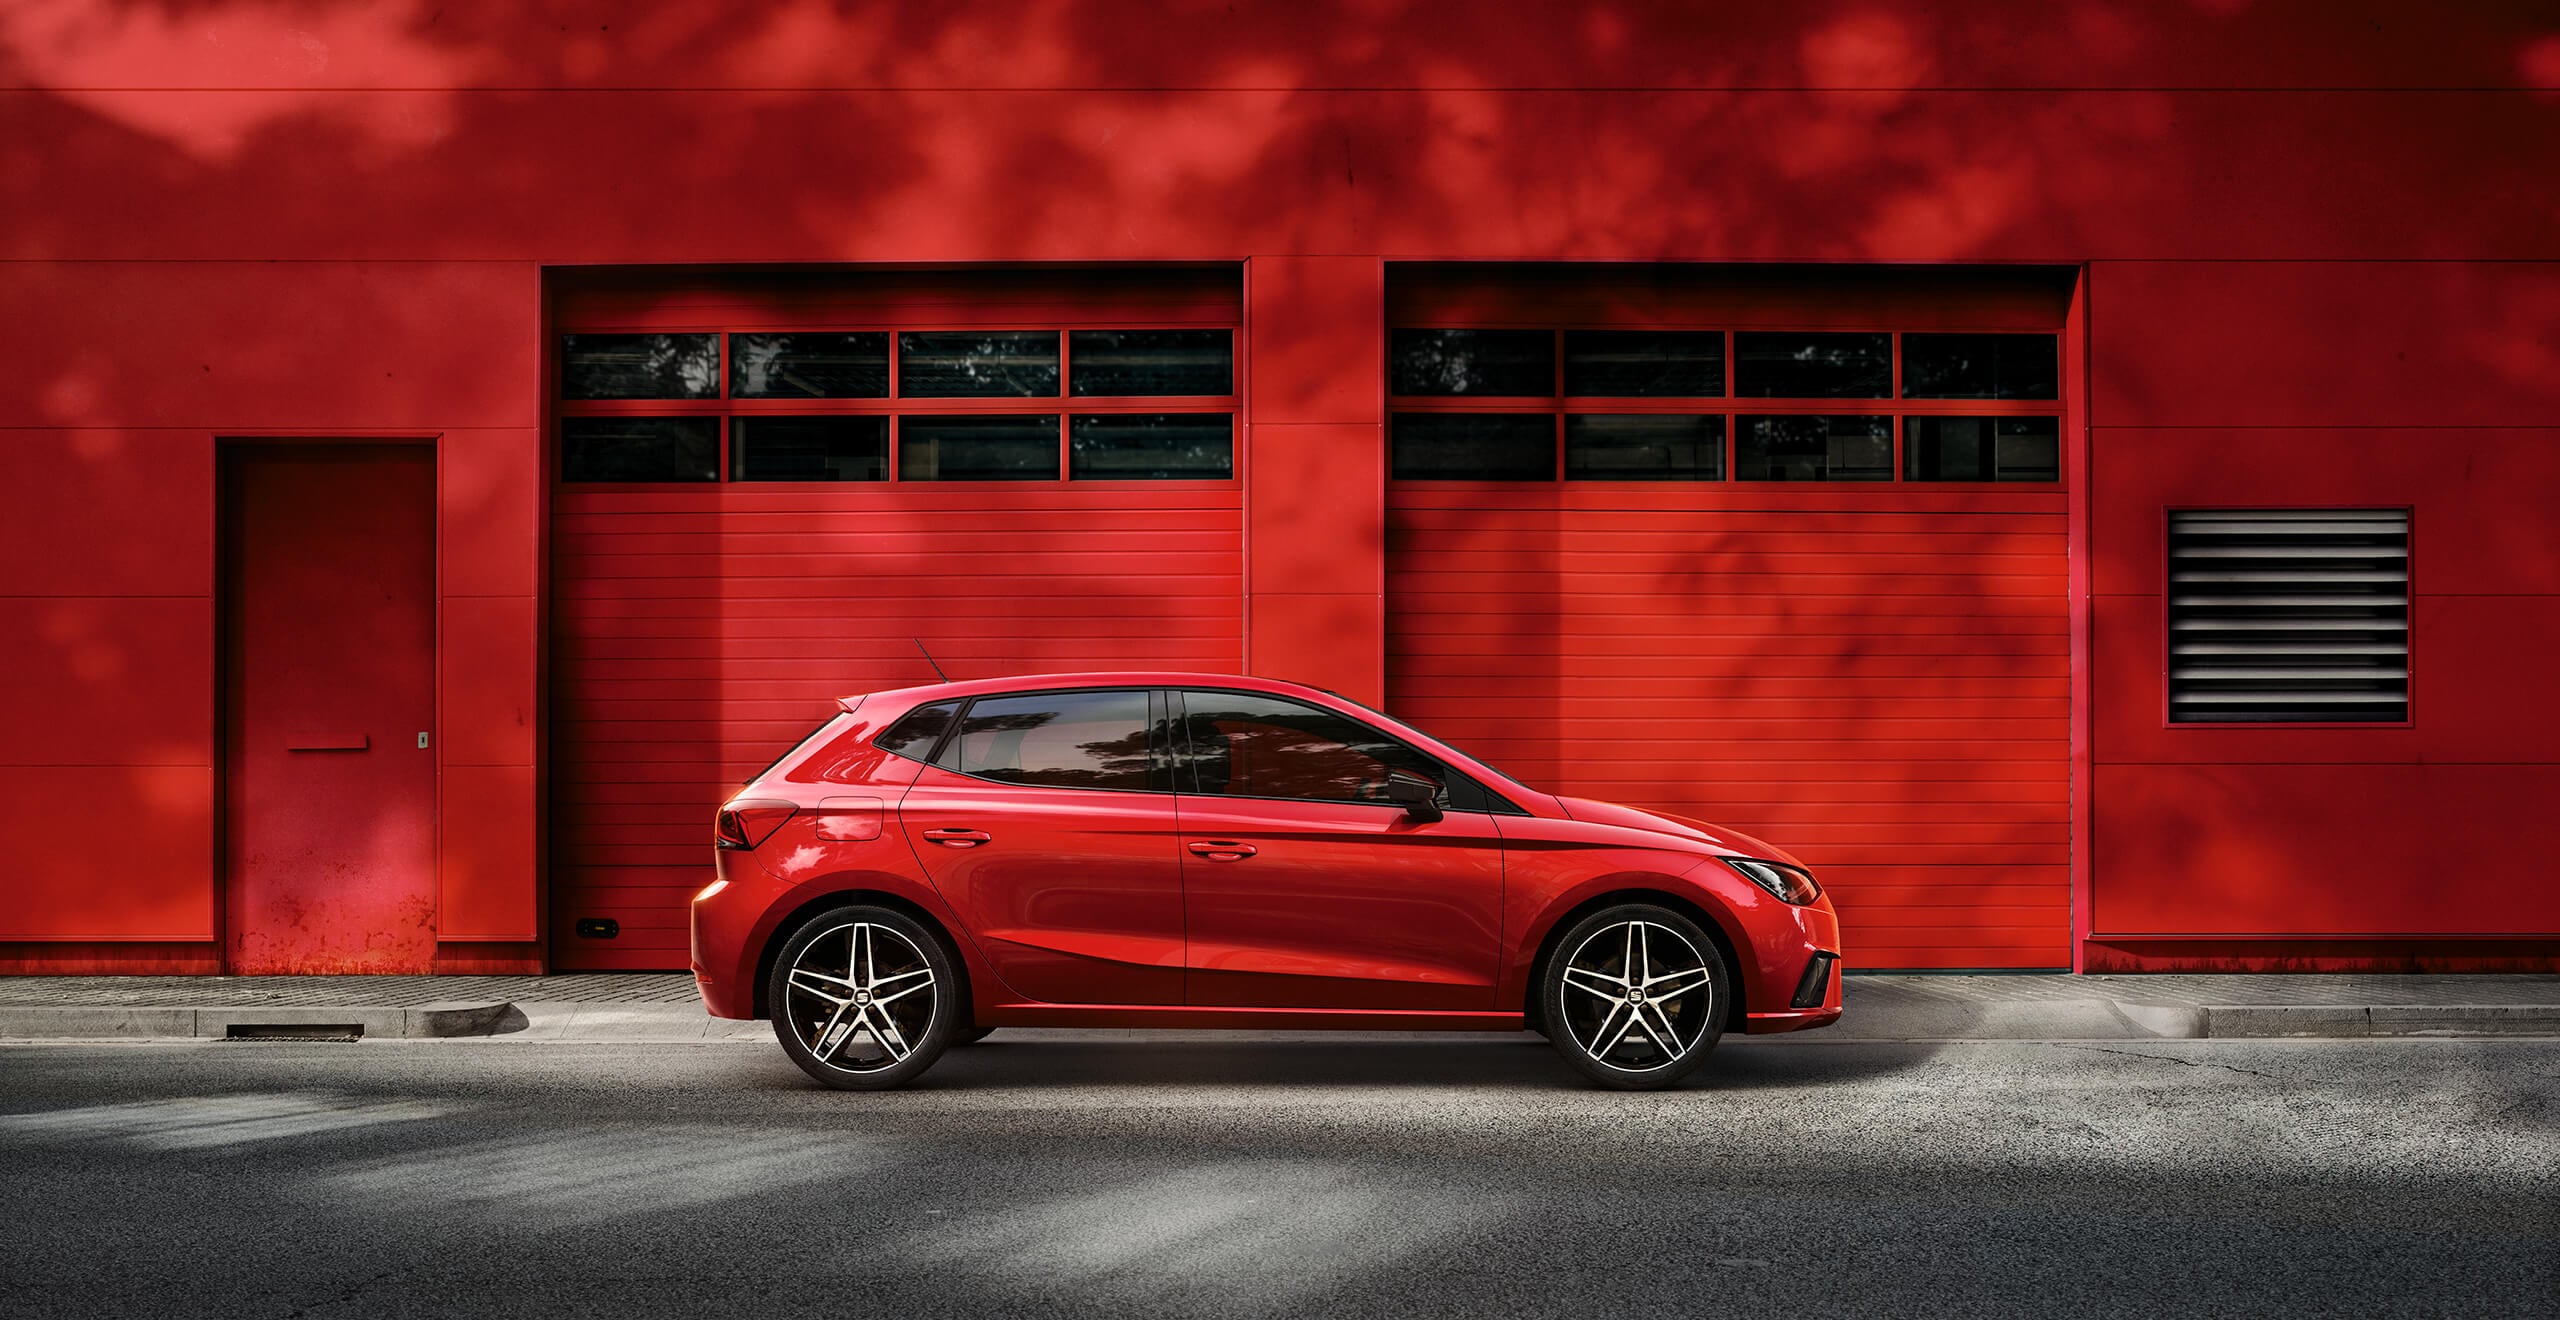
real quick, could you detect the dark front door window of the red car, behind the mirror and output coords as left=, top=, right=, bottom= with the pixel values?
left=1175, top=691, right=1449, bottom=803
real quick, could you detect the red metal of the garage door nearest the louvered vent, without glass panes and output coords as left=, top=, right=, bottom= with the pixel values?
left=1388, top=268, right=2071, bottom=967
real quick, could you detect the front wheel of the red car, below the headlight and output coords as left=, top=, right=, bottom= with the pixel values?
left=1539, top=903, right=1733, bottom=1090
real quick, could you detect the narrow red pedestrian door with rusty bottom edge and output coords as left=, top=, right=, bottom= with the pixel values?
left=223, top=443, right=435, bottom=975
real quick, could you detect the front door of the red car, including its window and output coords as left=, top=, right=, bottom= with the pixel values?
left=1175, top=691, right=1503, bottom=1010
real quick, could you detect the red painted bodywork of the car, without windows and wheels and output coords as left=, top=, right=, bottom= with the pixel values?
left=691, top=670, right=1841, bottom=1031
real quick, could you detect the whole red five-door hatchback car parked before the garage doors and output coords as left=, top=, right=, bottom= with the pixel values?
left=694, top=673, right=1841, bottom=1090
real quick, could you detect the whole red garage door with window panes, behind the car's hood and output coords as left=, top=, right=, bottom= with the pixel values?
left=1388, top=271, right=2074, bottom=967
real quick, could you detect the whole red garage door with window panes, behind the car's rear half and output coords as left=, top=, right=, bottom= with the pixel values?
left=550, top=269, right=1244, bottom=967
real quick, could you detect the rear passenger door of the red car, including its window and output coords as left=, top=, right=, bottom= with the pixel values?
left=899, top=688, right=1183, bottom=1003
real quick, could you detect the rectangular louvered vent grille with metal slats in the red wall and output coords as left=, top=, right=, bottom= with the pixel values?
left=2168, top=509, right=2409, bottom=724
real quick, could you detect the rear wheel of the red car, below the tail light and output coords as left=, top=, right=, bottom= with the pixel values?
left=765, top=903, right=968, bottom=1090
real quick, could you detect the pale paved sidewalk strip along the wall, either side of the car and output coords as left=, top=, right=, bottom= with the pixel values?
left=0, top=972, right=2560, bottom=1044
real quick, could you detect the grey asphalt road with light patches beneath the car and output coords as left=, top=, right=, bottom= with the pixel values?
left=0, top=1031, right=2560, bottom=1320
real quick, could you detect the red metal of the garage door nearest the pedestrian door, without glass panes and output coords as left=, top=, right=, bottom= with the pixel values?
left=550, top=269, right=1244, bottom=970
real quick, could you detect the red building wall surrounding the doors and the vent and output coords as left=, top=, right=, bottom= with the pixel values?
left=0, top=0, right=2560, bottom=967
